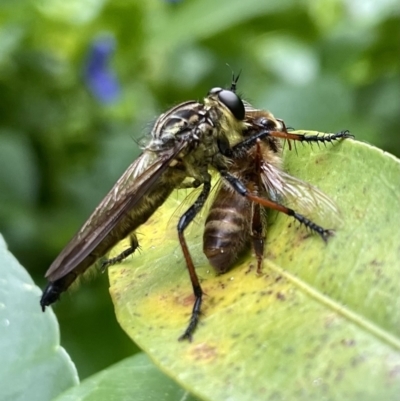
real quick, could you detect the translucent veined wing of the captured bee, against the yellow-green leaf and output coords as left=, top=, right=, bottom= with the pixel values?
left=261, top=162, right=341, bottom=228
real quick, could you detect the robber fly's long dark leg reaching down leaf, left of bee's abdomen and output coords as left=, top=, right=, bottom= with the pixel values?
left=178, top=175, right=211, bottom=341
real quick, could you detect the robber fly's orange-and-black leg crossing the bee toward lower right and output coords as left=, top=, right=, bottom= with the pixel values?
left=220, top=170, right=333, bottom=242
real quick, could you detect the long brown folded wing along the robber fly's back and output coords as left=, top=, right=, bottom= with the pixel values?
left=45, top=142, right=186, bottom=281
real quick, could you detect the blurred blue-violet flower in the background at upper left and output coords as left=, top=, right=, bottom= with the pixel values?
left=84, top=36, right=120, bottom=103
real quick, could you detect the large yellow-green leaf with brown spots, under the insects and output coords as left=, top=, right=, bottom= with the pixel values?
left=110, top=140, right=400, bottom=400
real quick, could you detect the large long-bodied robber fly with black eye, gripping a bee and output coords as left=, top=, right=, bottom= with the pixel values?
left=40, top=77, right=350, bottom=340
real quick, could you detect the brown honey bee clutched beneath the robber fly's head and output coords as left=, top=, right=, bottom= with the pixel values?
left=203, top=101, right=351, bottom=274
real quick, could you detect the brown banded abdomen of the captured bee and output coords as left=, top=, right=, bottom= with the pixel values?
left=203, top=196, right=250, bottom=273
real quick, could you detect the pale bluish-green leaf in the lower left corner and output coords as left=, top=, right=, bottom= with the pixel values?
left=0, top=236, right=78, bottom=401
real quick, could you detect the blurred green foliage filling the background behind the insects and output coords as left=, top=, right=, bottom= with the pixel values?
left=0, top=0, right=400, bottom=378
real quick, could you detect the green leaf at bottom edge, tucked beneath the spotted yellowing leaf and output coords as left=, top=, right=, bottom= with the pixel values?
left=57, top=353, right=200, bottom=401
